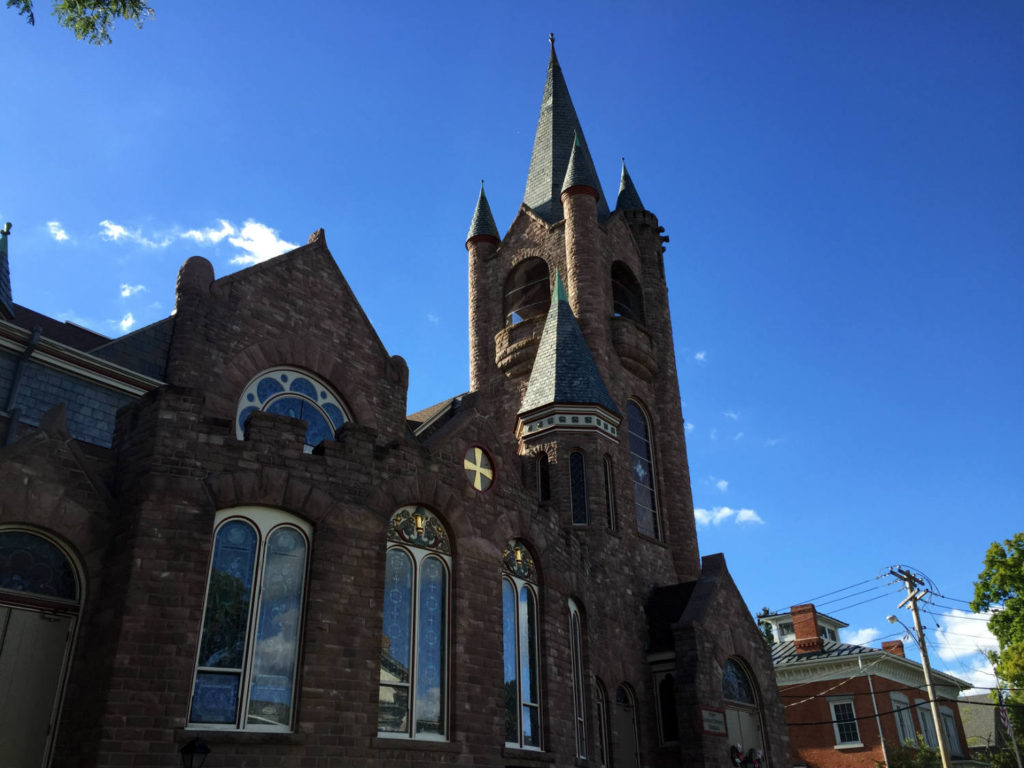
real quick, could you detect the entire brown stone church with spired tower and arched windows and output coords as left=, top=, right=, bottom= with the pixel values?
left=0, top=44, right=791, bottom=768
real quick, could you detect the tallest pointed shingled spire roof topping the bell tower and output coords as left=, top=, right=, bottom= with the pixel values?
left=522, top=38, right=608, bottom=223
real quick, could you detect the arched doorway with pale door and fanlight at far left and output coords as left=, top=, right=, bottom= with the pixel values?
left=0, top=528, right=82, bottom=767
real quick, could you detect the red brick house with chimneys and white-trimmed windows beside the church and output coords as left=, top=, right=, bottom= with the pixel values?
left=760, top=604, right=972, bottom=768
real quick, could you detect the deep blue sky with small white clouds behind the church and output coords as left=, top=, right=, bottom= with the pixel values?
left=0, top=0, right=1024, bottom=696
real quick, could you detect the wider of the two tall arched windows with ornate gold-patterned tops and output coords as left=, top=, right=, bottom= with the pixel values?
left=377, top=507, right=452, bottom=740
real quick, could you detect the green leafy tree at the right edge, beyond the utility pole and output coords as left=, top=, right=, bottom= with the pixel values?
left=971, top=534, right=1024, bottom=688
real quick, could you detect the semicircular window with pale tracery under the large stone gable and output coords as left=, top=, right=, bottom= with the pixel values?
left=234, top=368, right=349, bottom=451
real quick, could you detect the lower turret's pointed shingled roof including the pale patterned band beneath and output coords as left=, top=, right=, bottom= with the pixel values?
left=517, top=271, right=622, bottom=439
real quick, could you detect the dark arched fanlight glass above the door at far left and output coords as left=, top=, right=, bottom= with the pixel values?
left=0, top=530, right=78, bottom=601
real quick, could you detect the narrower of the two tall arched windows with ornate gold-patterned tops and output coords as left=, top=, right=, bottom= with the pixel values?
left=502, top=540, right=541, bottom=750
